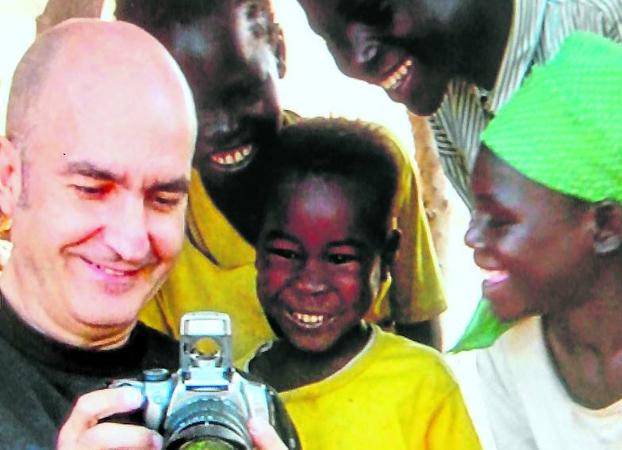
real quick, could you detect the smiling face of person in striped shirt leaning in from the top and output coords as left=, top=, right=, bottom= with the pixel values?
left=299, top=0, right=460, bottom=115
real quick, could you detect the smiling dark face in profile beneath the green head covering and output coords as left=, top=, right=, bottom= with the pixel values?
left=465, top=149, right=595, bottom=320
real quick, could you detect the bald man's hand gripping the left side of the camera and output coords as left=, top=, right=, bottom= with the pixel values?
left=56, top=387, right=163, bottom=450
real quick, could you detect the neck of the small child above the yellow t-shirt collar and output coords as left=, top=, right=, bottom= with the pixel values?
left=250, top=323, right=371, bottom=392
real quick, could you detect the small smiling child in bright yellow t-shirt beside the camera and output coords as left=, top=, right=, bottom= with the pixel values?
left=248, top=119, right=480, bottom=450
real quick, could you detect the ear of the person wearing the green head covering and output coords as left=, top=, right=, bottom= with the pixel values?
left=593, top=200, right=622, bottom=255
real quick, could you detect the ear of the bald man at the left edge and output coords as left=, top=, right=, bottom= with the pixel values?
left=0, top=136, right=22, bottom=219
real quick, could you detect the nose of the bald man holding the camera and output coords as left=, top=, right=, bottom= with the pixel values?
left=105, top=197, right=151, bottom=264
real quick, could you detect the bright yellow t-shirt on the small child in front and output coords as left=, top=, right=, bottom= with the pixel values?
left=268, top=326, right=481, bottom=450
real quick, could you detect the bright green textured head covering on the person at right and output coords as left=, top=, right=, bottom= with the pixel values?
left=482, top=32, right=622, bottom=203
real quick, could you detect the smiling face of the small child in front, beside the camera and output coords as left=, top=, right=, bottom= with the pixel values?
left=256, top=177, right=383, bottom=352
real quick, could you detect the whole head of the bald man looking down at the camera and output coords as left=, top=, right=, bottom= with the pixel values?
left=0, top=19, right=196, bottom=346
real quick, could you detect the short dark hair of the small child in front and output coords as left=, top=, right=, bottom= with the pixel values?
left=259, top=117, right=401, bottom=243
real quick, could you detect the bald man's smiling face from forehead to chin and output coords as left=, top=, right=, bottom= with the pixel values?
left=8, top=81, right=194, bottom=338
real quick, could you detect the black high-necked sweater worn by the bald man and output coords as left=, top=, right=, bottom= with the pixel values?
left=0, top=293, right=179, bottom=450
